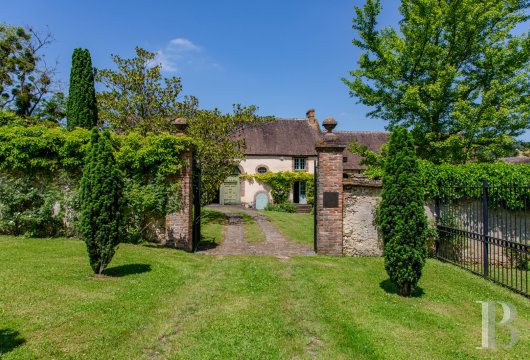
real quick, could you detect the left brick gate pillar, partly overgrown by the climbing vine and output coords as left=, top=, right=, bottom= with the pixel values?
left=165, top=153, right=193, bottom=251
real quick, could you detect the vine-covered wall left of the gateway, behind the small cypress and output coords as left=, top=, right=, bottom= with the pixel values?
left=0, top=125, right=193, bottom=241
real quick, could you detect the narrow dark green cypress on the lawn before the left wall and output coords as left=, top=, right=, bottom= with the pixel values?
left=80, top=129, right=124, bottom=274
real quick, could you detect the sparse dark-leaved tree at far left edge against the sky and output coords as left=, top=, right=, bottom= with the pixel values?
left=0, top=24, right=55, bottom=116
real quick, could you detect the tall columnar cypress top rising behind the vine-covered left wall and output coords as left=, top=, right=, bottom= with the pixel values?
left=66, top=49, right=98, bottom=130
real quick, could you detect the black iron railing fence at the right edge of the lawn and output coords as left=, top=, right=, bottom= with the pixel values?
left=435, top=180, right=530, bottom=296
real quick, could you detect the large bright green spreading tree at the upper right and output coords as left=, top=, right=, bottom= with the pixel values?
left=343, top=0, right=530, bottom=163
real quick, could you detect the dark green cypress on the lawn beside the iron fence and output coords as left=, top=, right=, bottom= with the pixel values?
left=378, top=126, right=427, bottom=296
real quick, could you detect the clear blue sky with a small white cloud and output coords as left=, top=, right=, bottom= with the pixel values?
left=0, top=0, right=530, bottom=140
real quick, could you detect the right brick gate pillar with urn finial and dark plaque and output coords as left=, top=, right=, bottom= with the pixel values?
left=316, top=118, right=346, bottom=256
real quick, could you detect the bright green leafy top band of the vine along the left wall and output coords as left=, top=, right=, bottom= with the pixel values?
left=0, top=126, right=193, bottom=176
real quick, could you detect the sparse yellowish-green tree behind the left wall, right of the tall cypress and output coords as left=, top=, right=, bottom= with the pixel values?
left=96, top=47, right=197, bottom=135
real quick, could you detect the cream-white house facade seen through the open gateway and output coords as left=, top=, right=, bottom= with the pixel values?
left=240, top=155, right=317, bottom=206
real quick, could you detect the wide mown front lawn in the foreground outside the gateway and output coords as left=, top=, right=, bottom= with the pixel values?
left=0, top=237, right=530, bottom=359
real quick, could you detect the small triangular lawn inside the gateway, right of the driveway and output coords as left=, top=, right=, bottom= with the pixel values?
left=259, top=211, right=314, bottom=245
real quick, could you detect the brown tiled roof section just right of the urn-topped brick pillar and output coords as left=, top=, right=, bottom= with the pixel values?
left=335, top=131, right=390, bottom=171
